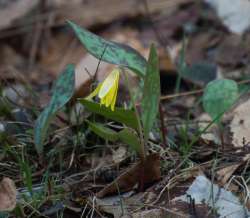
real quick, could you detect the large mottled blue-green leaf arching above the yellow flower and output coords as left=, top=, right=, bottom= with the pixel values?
left=68, top=21, right=147, bottom=76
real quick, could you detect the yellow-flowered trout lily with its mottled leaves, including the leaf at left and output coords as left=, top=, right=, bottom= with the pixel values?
left=34, top=21, right=160, bottom=160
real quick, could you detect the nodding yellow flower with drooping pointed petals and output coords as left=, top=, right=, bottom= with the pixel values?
left=87, top=69, right=120, bottom=111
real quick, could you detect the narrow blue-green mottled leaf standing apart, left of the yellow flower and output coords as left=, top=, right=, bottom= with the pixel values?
left=34, top=64, right=75, bottom=154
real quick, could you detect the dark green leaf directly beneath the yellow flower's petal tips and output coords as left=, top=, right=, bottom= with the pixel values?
left=80, top=99, right=138, bottom=129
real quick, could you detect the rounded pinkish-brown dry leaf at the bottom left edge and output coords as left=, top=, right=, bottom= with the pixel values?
left=0, top=178, right=17, bottom=211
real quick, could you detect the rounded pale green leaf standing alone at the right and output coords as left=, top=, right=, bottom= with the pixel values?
left=202, top=79, right=239, bottom=122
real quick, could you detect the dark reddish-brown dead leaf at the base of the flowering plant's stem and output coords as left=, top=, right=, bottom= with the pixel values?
left=97, top=153, right=161, bottom=198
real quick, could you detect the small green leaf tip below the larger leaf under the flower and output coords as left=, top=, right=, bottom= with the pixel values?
left=87, top=121, right=118, bottom=142
